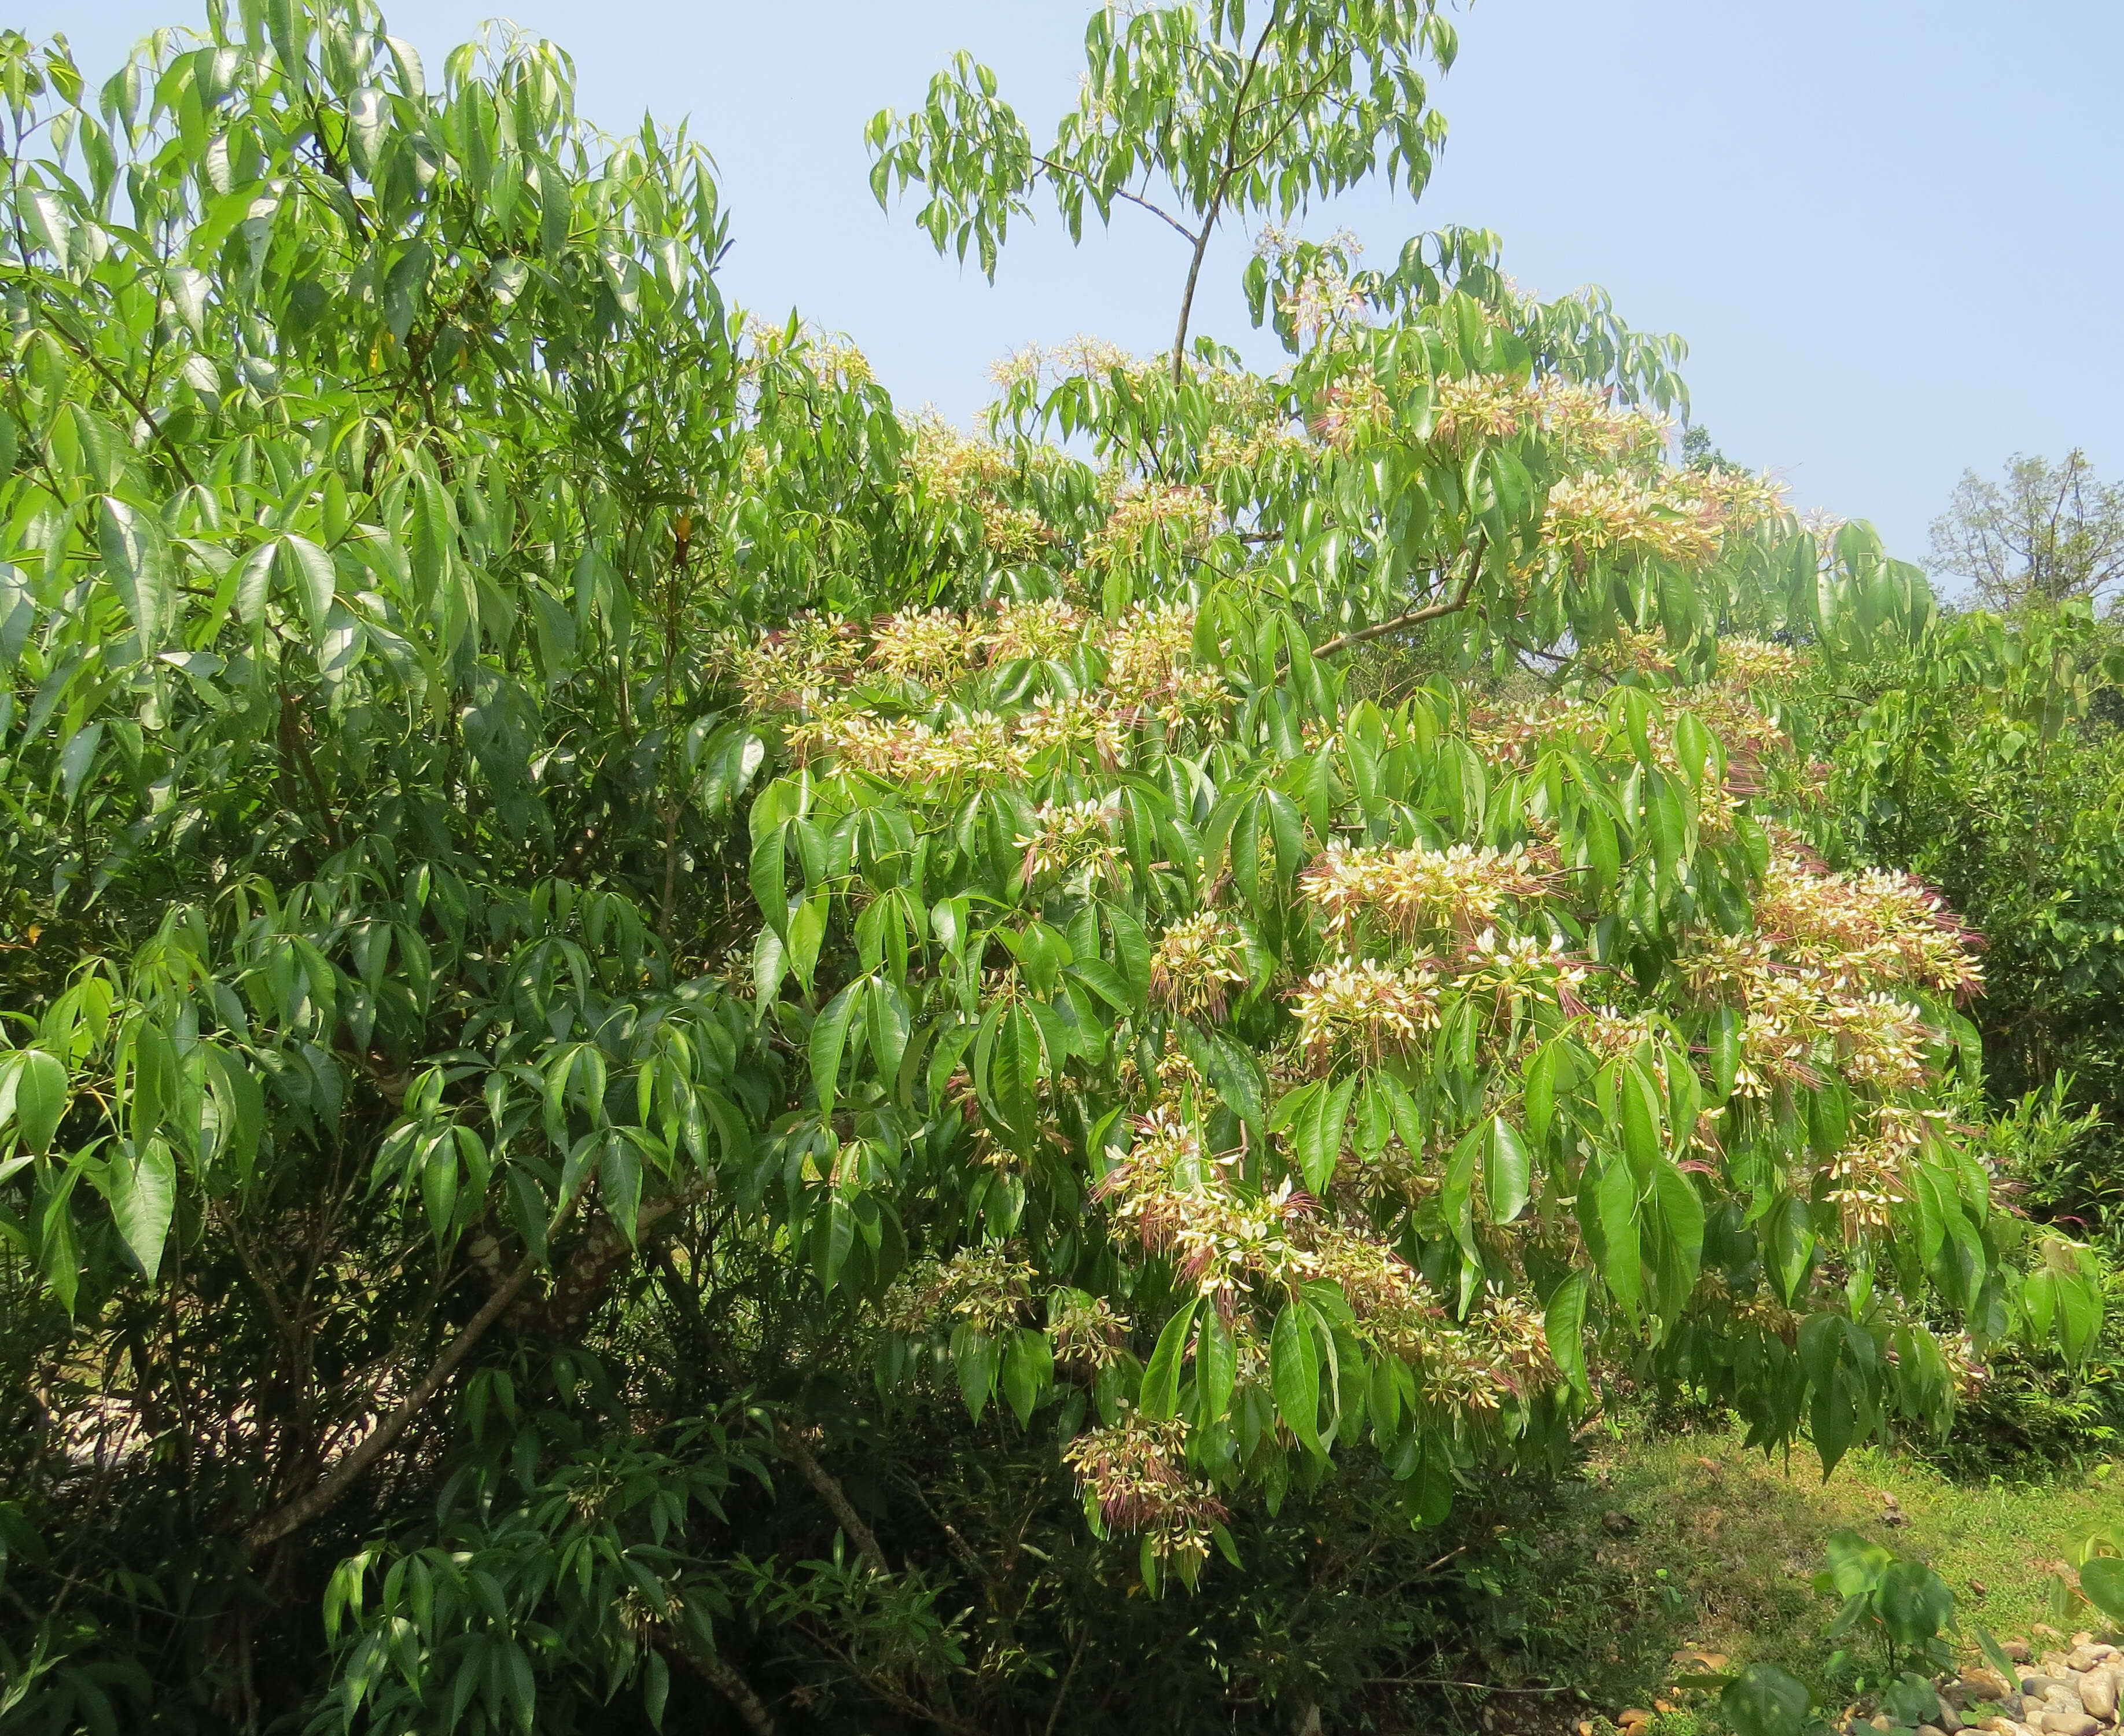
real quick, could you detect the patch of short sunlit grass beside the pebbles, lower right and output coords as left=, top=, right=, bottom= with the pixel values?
left=1523, top=1422, right=2124, bottom=1736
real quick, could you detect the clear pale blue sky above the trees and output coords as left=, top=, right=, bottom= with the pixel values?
left=20, top=0, right=2124, bottom=557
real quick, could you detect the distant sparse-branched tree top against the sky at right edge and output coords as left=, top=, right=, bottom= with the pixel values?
left=1931, top=446, right=2124, bottom=610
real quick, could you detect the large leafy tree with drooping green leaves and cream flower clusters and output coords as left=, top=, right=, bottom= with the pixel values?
left=0, top=0, right=2099, bottom=1732
